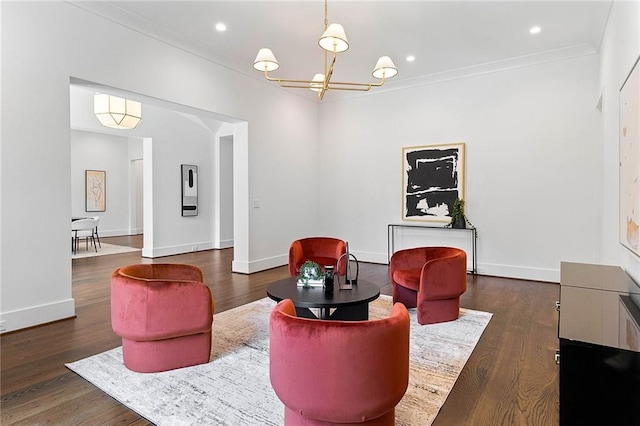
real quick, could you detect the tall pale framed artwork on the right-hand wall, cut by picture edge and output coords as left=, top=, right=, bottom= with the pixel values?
left=619, top=58, right=640, bottom=256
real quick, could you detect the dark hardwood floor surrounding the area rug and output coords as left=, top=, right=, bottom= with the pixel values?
left=0, top=236, right=559, bottom=426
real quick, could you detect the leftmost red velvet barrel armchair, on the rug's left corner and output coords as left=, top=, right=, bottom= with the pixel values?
left=111, top=263, right=214, bottom=373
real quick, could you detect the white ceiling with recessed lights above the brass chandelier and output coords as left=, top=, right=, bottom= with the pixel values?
left=69, top=0, right=612, bottom=100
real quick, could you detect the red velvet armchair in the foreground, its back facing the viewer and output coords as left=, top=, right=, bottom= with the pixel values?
left=269, top=299, right=409, bottom=426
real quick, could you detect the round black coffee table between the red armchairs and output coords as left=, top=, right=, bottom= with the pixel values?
left=267, top=277, right=380, bottom=321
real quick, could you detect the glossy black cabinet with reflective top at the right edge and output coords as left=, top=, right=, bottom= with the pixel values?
left=557, top=262, right=640, bottom=425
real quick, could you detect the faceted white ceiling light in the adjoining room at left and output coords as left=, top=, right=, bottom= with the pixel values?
left=93, top=94, right=142, bottom=129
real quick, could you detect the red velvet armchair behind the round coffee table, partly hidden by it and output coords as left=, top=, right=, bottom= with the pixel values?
left=289, top=237, right=347, bottom=277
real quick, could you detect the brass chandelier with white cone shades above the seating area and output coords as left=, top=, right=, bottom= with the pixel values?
left=253, top=0, right=398, bottom=99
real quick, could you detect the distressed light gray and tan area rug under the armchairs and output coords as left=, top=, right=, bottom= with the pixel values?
left=66, top=296, right=492, bottom=426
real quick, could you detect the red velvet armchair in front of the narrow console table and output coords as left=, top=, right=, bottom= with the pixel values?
left=389, top=247, right=467, bottom=324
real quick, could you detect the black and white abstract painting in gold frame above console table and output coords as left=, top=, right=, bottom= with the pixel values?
left=402, top=142, right=465, bottom=223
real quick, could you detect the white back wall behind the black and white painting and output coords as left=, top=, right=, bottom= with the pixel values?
left=320, top=55, right=600, bottom=281
